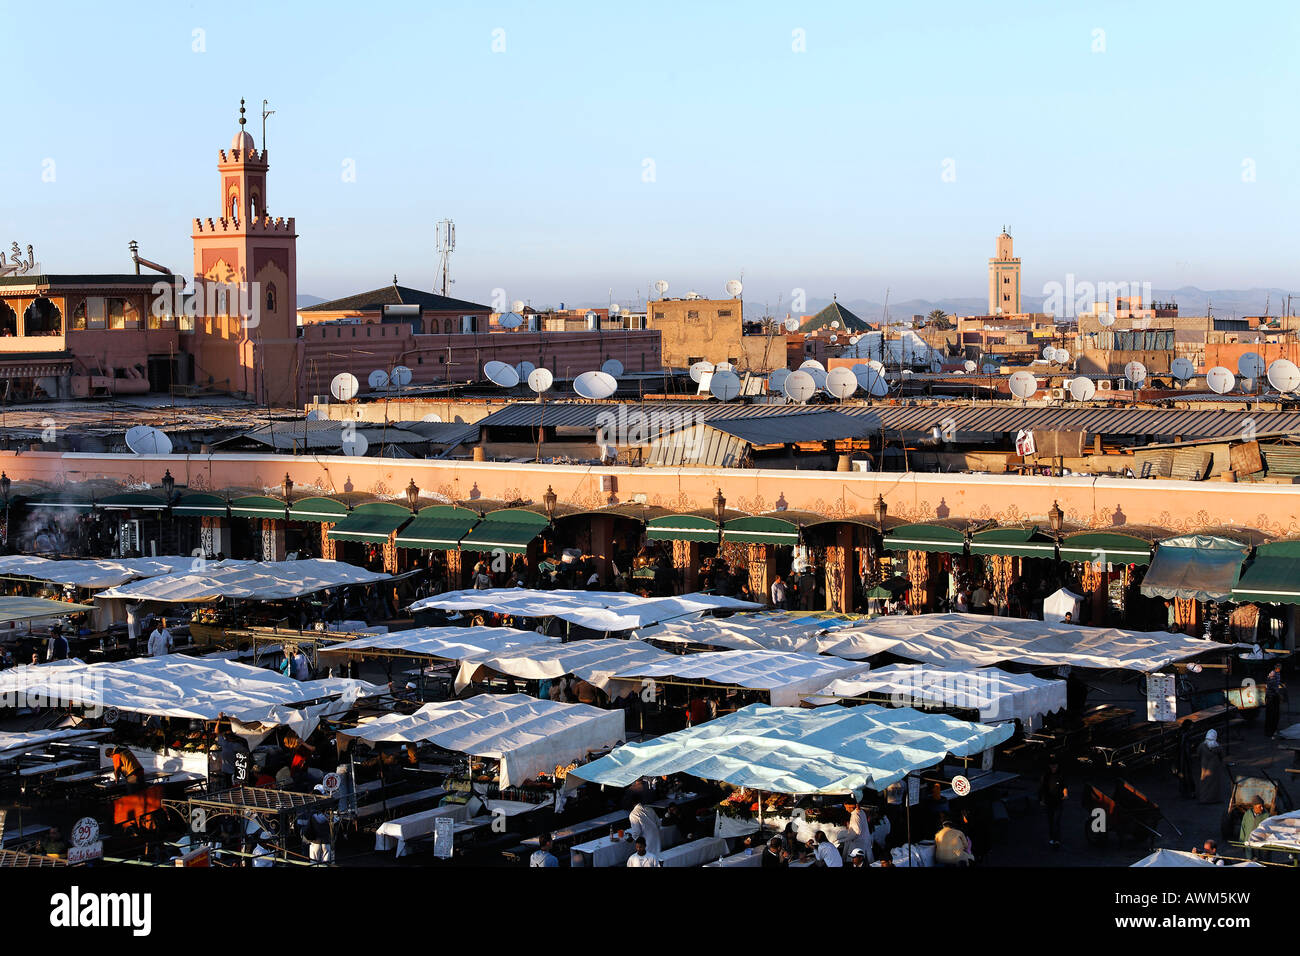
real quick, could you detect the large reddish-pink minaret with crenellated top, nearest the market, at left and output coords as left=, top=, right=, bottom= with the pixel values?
left=191, top=100, right=298, bottom=405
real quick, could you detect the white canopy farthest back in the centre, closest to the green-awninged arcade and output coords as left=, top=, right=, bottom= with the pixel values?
left=411, top=588, right=761, bottom=633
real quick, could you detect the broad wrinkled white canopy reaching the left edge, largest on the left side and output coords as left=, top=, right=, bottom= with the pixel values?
left=0, top=654, right=384, bottom=723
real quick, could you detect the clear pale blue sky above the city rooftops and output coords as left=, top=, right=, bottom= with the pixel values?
left=0, top=0, right=1300, bottom=312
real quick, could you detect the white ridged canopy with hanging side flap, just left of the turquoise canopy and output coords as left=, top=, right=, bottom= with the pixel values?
left=339, top=693, right=624, bottom=787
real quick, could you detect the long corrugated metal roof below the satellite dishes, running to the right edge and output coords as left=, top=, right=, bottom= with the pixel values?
left=478, top=402, right=1300, bottom=440
